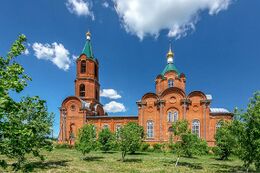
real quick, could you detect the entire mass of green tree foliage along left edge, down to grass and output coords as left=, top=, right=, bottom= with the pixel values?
left=0, top=35, right=53, bottom=170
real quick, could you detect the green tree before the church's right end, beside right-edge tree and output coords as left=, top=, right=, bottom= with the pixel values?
left=213, top=121, right=236, bottom=160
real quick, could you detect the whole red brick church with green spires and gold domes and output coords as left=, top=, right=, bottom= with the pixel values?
left=59, top=32, right=233, bottom=146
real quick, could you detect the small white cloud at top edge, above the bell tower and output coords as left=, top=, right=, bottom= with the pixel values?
left=66, top=0, right=95, bottom=20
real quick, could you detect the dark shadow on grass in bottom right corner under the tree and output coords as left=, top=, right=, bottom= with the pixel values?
left=211, top=163, right=256, bottom=173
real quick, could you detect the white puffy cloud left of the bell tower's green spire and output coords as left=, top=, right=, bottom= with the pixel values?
left=32, top=42, right=71, bottom=71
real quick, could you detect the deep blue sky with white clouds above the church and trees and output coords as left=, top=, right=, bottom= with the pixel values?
left=0, top=0, right=260, bottom=135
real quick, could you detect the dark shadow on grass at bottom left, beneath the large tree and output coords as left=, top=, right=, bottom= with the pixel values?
left=24, top=160, right=71, bottom=172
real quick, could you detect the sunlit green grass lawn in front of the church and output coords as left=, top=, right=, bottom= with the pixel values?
left=0, top=149, right=253, bottom=173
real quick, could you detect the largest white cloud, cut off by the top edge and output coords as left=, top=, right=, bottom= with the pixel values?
left=113, top=0, right=234, bottom=39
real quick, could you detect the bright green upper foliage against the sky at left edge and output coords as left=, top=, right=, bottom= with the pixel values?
left=0, top=35, right=31, bottom=115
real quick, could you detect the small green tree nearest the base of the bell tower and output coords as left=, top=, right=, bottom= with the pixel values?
left=76, top=124, right=97, bottom=156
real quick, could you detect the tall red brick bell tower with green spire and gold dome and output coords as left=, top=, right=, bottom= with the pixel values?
left=75, top=31, right=100, bottom=104
